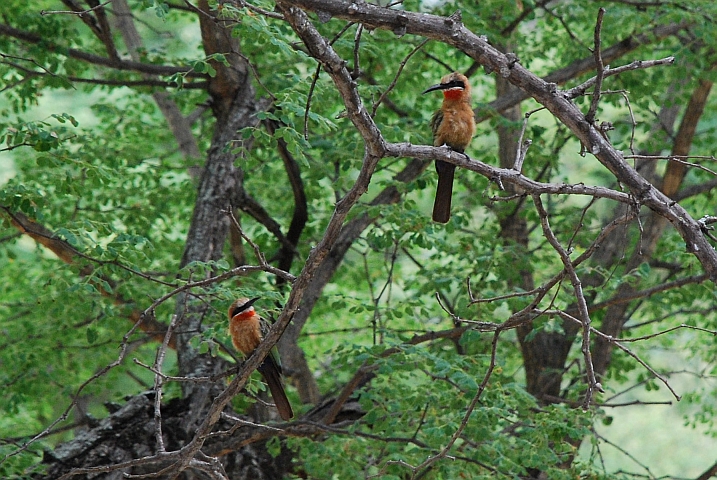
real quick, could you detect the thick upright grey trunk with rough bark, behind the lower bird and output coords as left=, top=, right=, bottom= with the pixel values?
left=175, top=1, right=260, bottom=390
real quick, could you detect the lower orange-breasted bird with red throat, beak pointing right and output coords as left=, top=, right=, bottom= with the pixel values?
left=228, top=297, right=294, bottom=421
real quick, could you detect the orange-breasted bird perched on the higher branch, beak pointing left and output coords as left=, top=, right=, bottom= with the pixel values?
left=423, top=72, right=476, bottom=223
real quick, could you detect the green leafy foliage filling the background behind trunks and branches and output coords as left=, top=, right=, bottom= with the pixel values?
left=0, top=0, right=717, bottom=479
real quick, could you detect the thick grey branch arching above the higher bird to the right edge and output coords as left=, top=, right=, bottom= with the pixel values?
left=285, top=0, right=717, bottom=282
